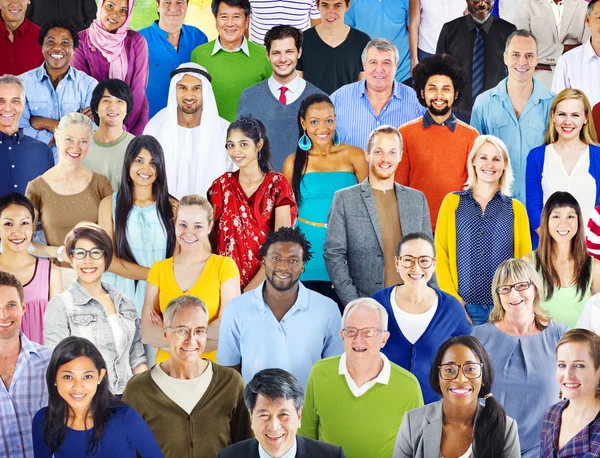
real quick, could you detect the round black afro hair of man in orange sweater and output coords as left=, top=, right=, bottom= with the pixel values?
left=413, top=54, right=467, bottom=107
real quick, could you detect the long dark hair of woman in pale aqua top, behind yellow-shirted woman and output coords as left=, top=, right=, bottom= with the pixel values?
left=115, top=135, right=175, bottom=264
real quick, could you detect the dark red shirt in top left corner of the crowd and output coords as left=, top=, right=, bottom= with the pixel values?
left=0, top=19, right=44, bottom=76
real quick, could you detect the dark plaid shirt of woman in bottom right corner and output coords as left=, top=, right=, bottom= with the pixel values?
left=540, top=399, right=600, bottom=458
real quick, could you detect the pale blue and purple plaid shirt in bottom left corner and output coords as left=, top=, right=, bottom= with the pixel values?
left=0, top=333, right=51, bottom=458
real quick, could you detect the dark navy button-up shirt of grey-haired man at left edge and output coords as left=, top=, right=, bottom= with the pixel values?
left=0, top=129, right=54, bottom=195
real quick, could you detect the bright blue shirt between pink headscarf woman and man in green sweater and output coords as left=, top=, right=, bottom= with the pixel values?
left=139, top=20, right=208, bottom=119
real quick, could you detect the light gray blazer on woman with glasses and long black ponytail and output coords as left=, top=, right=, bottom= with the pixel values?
left=393, top=401, right=521, bottom=458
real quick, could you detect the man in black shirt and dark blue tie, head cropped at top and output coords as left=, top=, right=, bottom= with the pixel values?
left=436, top=0, right=516, bottom=122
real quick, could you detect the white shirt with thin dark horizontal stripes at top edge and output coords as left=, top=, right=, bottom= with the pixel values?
left=250, top=0, right=321, bottom=45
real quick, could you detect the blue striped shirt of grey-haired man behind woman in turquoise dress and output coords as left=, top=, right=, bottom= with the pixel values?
left=331, top=80, right=426, bottom=149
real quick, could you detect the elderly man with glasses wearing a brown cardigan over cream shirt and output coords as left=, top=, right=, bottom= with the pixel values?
left=123, top=295, right=252, bottom=458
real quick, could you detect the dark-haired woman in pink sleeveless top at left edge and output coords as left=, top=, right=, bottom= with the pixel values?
left=0, top=192, right=62, bottom=345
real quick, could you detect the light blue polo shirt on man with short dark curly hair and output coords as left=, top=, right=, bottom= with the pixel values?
left=217, top=282, right=344, bottom=388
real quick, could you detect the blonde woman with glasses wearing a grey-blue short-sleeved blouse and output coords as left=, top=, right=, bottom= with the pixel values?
left=472, top=259, right=567, bottom=458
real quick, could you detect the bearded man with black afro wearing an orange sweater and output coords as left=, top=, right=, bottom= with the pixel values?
left=395, top=54, right=479, bottom=232
